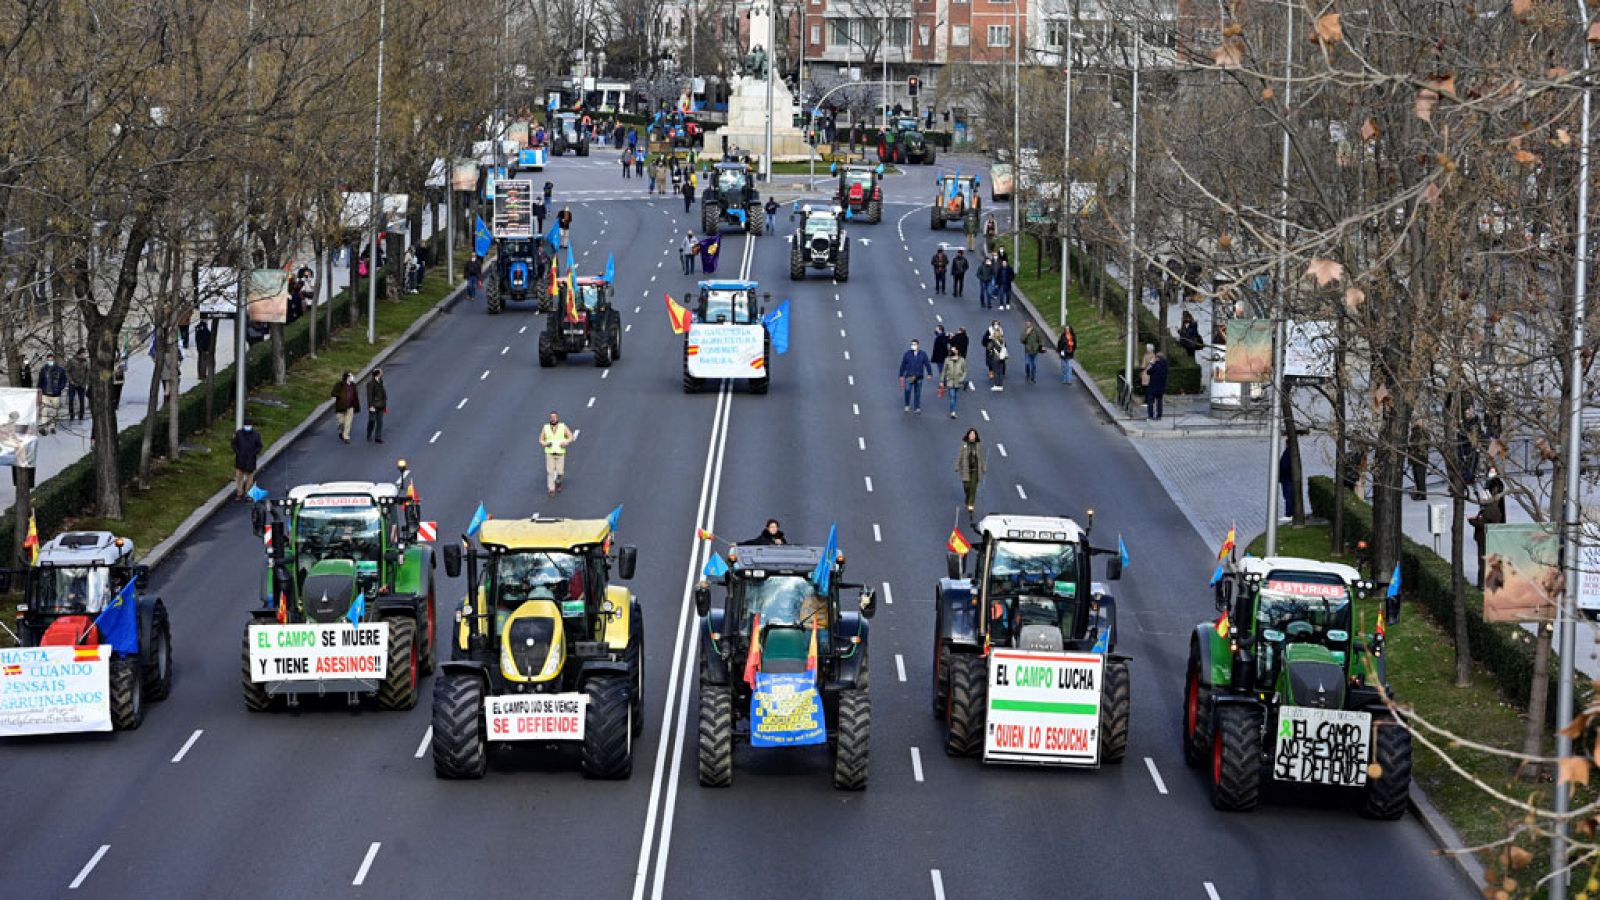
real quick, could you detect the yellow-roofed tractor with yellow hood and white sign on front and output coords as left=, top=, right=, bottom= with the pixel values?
left=434, top=516, right=645, bottom=778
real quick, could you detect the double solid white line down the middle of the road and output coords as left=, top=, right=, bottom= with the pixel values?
left=634, top=229, right=757, bottom=900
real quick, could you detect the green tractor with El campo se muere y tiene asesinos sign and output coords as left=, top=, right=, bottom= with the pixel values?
left=242, top=460, right=437, bottom=713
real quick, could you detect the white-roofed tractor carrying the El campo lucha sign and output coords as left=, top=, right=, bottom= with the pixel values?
left=933, top=512, right=1131, bottom=767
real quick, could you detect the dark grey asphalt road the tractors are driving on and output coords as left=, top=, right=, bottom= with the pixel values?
left=0, top=152, right=1470, bottom=898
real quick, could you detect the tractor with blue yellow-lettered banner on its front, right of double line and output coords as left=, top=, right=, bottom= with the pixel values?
left=694, top=531, right=877, bottom=791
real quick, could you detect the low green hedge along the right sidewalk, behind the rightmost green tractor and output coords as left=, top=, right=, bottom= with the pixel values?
left=1307, top=476, right=1555, bottom=722
